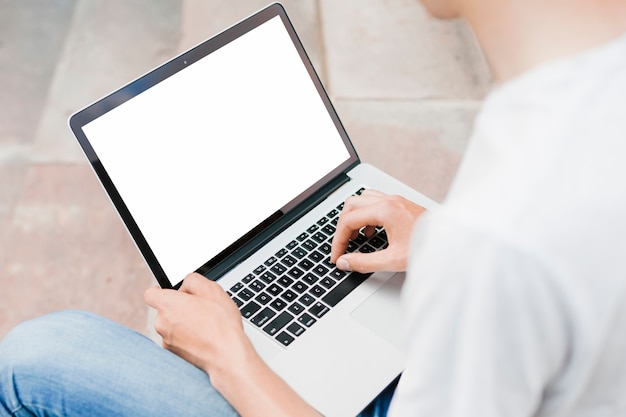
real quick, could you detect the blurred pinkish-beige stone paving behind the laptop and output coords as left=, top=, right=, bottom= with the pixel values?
left=0, top=0, right=491, bottom=338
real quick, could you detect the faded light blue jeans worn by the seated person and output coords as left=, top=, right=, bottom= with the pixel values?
left=0, top=311, right=393, bottom=417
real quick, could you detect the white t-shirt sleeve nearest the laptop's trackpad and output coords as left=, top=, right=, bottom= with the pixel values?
left=389, top=214, right=567, bottom=417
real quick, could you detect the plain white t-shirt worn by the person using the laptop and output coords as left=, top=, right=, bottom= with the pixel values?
left=388, top=30, right=626, bottom=417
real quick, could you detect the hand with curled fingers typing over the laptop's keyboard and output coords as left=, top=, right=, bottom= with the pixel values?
left=330, top=190, right=424, bottom=272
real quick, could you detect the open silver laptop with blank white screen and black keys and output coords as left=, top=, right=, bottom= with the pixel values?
left=69, top=3, right=436, bottom=416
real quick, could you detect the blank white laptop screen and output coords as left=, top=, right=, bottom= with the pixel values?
left=76, top=16, right=351, bottom=286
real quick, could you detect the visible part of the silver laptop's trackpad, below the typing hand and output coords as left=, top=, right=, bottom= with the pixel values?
left=350, top=273, right=404, bottom=349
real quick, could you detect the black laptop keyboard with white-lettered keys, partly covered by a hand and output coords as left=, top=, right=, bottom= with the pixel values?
left=227, top=188, right=388, bottom=346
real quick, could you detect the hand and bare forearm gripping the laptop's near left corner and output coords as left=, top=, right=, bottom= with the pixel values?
left=145, top=274, right=320, bottom=417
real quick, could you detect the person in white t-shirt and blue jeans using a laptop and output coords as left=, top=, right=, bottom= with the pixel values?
left=0, top=0, right=626, bottom=417
